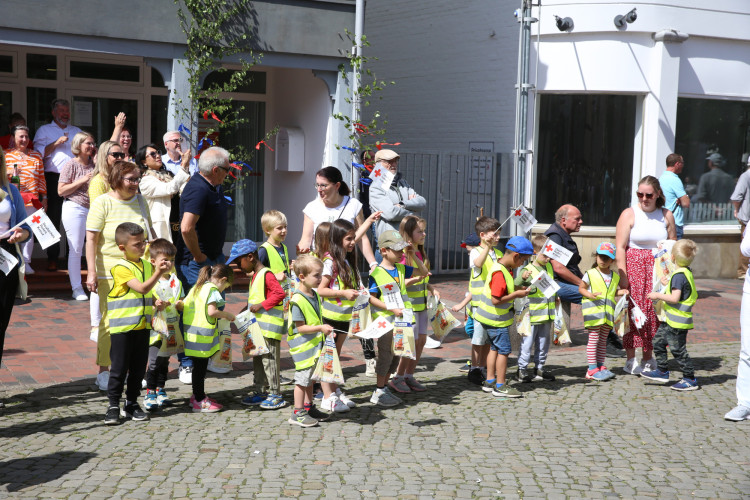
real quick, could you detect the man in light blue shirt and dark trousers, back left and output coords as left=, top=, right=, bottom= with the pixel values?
left=34, top=99, right=81, bottom=271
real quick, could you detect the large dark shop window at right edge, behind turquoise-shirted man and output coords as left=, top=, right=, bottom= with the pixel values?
left=675, top=98, right=750, bottom=224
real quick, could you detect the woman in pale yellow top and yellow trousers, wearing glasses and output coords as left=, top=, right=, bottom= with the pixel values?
left=86, top=160, right=151, bottom=390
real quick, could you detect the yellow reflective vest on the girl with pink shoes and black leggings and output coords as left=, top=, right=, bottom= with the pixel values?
left=183, top=281, right=219, bottom=358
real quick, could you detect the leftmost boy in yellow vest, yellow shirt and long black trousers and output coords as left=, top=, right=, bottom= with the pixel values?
left=104, top=222, right=171, bottom=425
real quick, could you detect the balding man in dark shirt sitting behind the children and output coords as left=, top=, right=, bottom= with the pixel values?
left=544, top=205, right=625, bottom=357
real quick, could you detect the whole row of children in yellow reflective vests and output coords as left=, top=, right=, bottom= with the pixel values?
left=105, top=210, right=697, bottom=427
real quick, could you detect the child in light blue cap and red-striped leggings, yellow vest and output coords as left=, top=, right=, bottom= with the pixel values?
left=578, top=241, right=628, bottom=382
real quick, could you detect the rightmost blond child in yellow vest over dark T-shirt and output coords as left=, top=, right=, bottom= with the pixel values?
left=641, top=240, right=699, bottom=391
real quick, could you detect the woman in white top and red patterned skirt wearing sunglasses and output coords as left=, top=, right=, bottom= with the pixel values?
left=615, top=175, right=677, bottom=375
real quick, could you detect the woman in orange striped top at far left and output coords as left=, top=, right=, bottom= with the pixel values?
left=5, top=125, right=47, bottom=274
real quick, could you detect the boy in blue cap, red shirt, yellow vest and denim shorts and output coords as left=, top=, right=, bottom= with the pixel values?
left=474, top=236, right=534, bottom=398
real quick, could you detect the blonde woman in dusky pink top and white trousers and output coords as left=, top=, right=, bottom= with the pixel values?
left=57, top=132, right=96, bottom=300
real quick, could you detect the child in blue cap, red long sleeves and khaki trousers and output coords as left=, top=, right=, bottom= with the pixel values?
left=227, top=240, right=286, bottom=410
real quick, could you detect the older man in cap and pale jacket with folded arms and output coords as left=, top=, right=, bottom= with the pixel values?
left=370, top=149, right=427, bottom=236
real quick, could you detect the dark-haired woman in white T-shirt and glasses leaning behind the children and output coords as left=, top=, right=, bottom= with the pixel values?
left=297, top=167, right=378, bottom=269
